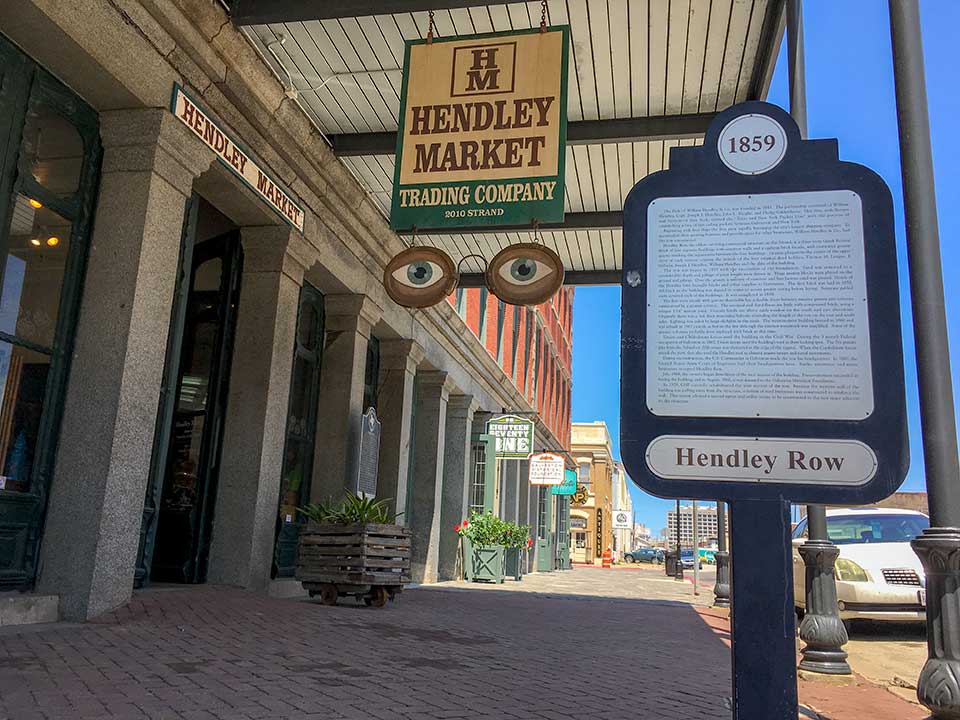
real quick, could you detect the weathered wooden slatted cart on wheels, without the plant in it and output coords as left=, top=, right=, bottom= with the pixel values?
left=296, top=523, right=410, bottom=607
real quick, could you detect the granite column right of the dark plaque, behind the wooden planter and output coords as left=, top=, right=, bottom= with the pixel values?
left=377, top=340, right=423, bottom=525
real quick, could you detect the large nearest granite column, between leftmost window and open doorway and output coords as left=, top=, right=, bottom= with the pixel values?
left=37, top=109, right=213, bottom=620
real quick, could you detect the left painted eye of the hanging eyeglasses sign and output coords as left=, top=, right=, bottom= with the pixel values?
left=383, top=247, right=459, bottom=308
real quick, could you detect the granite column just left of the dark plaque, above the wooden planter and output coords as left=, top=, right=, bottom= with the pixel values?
left=310, top=295, right=382, bottom=501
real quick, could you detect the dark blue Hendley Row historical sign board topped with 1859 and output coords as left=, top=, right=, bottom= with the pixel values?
left=620, top=102, right=908, bottom=504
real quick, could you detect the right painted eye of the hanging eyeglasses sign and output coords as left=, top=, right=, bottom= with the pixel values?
left=487, top=243, right=563, bottom=305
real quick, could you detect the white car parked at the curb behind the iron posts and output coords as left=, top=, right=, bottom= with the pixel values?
left=793, top=508, right=930, bottom=622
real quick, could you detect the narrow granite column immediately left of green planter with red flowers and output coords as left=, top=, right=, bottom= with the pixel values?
left=438, top=395, right=478, bottom=580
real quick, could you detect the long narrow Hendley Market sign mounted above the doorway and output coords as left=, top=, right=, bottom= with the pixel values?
left=170, top=84, right=303, bottom=232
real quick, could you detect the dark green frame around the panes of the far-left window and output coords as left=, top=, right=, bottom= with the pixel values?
left=0, top=35, right=102, bottom=590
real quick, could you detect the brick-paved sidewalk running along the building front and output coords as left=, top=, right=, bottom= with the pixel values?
left=0, top=569, right=922, bottom=720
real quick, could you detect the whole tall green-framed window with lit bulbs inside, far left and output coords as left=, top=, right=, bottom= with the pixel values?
left=0, top=31, right=101, bottom=590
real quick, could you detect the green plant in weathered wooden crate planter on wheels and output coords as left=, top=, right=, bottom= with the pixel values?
left=296, top=492, right=410, bottom=607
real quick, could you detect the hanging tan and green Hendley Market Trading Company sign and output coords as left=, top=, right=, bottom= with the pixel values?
left=390, top=26, right=570, bottom=230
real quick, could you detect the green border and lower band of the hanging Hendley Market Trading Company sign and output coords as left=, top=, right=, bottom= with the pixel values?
left=390, top=25, right=570, bottom=232
